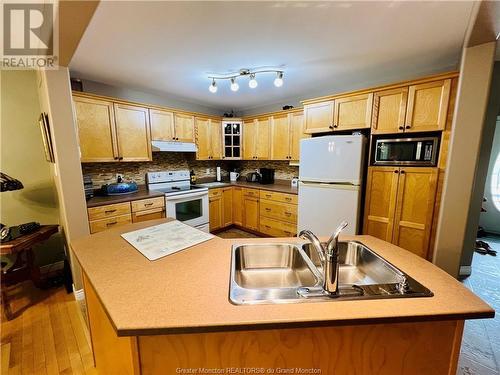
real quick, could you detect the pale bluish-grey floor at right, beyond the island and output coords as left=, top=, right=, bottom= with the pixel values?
left=457, top=237, right=500, bottom=375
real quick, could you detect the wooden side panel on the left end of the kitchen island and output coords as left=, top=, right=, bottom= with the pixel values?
left=83, top=273, right=142, bottom=375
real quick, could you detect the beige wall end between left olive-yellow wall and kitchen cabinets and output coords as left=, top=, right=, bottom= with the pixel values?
left=38, top=67, right=89, bottom=290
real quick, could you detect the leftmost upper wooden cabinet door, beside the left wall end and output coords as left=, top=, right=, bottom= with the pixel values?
left=73, top=96, right=118, bottom=163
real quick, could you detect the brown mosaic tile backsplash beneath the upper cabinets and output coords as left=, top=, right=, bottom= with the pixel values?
left=82, top=152, right=299, bottom=189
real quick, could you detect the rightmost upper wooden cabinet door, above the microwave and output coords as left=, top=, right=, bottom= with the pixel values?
left=405, top=79, right=451, bottom=132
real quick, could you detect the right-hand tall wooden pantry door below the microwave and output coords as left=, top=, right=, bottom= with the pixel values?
left=392, top=167, right=438, bottom=258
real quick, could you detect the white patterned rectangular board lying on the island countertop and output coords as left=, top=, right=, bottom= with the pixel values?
left=122, top=220, right=214, bottom=260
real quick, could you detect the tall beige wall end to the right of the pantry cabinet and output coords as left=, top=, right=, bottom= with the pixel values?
left=433, top=42, right=495, bottom=277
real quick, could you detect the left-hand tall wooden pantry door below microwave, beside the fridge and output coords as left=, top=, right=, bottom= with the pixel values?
left=363, top=167, right=399, bottom=242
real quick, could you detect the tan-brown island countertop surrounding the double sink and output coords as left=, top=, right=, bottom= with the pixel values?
left=71, top=219, right=494, bottom=336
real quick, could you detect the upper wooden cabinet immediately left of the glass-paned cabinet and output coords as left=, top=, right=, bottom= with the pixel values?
left=195, top=117, right=222, bottom=160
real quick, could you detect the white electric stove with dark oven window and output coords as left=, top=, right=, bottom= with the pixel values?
left=146, top=170, right=209, bottom=232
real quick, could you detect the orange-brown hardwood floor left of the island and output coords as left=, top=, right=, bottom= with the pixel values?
left=1, top=282, right=96, bottom=375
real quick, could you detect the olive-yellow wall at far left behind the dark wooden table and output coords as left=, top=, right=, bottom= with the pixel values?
left=0, top=70, right=64, bottom=264
